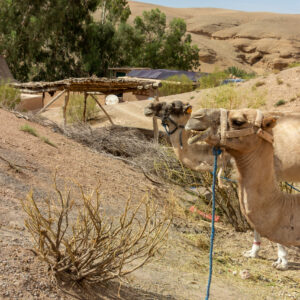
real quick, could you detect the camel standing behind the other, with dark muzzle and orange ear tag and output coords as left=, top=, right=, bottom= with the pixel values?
left=144, top=101, right=288, bottom=270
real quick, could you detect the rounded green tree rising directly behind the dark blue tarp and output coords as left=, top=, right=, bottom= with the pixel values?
left=119, top=9, right=199, bottom=70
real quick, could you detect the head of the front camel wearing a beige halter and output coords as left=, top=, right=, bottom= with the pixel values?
left=185, top=109, right=277, bottom=153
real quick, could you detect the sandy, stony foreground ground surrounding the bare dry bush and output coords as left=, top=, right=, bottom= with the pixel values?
left=0, top=98, right=300, bottom=300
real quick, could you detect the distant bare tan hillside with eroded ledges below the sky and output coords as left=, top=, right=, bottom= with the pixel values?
left=124, top=1, right=300, bottom=72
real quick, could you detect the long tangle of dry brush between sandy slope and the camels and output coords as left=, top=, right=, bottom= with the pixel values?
left=20, top=116, right=249, bottom=231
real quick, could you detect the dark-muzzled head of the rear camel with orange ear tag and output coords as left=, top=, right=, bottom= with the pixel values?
left=144, top=101, right=192, bottom=125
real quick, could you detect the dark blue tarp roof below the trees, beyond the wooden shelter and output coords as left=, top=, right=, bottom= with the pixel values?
left=127, top=69, right=206, bottom=82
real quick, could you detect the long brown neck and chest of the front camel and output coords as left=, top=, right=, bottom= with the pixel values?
left=231, top=140, right=300, bottom=246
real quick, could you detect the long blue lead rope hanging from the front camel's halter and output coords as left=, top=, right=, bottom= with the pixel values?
left=205, top=147, right=222, bottom=300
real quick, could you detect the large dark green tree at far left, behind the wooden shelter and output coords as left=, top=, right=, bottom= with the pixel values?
left=0, top=0, right=98, bottom=81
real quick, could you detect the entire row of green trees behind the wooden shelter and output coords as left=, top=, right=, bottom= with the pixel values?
left=0, top=0, right=199, bottom=81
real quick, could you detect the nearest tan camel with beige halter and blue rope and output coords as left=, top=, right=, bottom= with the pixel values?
left=186, top=109, right=300, bottom=247
